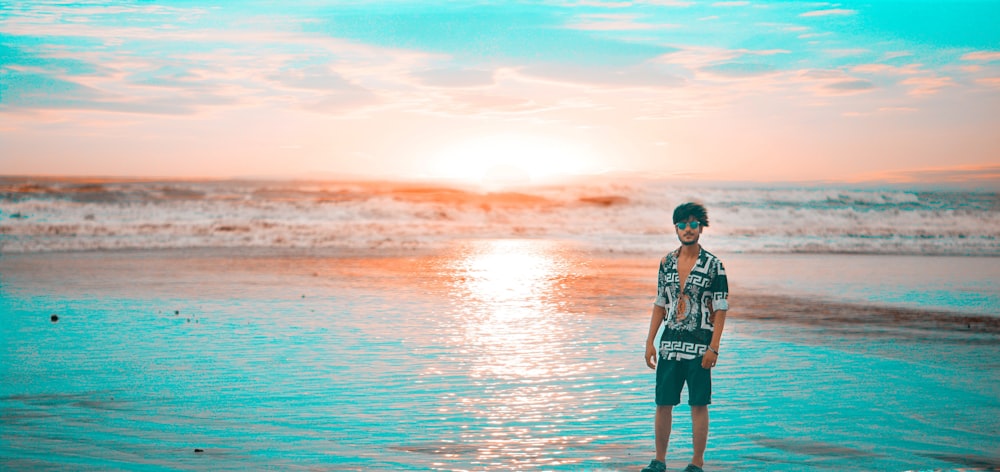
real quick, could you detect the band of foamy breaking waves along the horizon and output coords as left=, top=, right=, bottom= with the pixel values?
left=0, top=178, right=1000, bottom=256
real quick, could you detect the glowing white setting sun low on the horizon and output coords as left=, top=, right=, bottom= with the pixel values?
left=428, top=134, right=596, bottom=188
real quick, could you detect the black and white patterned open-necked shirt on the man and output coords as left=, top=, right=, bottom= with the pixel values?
left=654, top=249, right=729, bottom=360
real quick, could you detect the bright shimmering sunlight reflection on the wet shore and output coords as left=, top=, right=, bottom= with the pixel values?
left=442, top=240, right=595, bottom=469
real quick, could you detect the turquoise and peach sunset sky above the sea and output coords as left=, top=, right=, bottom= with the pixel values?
left=0, top=0, right=1000, bottom=186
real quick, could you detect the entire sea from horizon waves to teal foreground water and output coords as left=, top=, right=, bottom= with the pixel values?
left=0, top=178, right=1000, bottom=471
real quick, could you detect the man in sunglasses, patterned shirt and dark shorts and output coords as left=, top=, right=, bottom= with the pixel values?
left=642, top=203, right=729, bottom=472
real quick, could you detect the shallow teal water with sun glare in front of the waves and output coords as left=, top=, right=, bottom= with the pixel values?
left=0, top=240, right=1000, bottom=471
